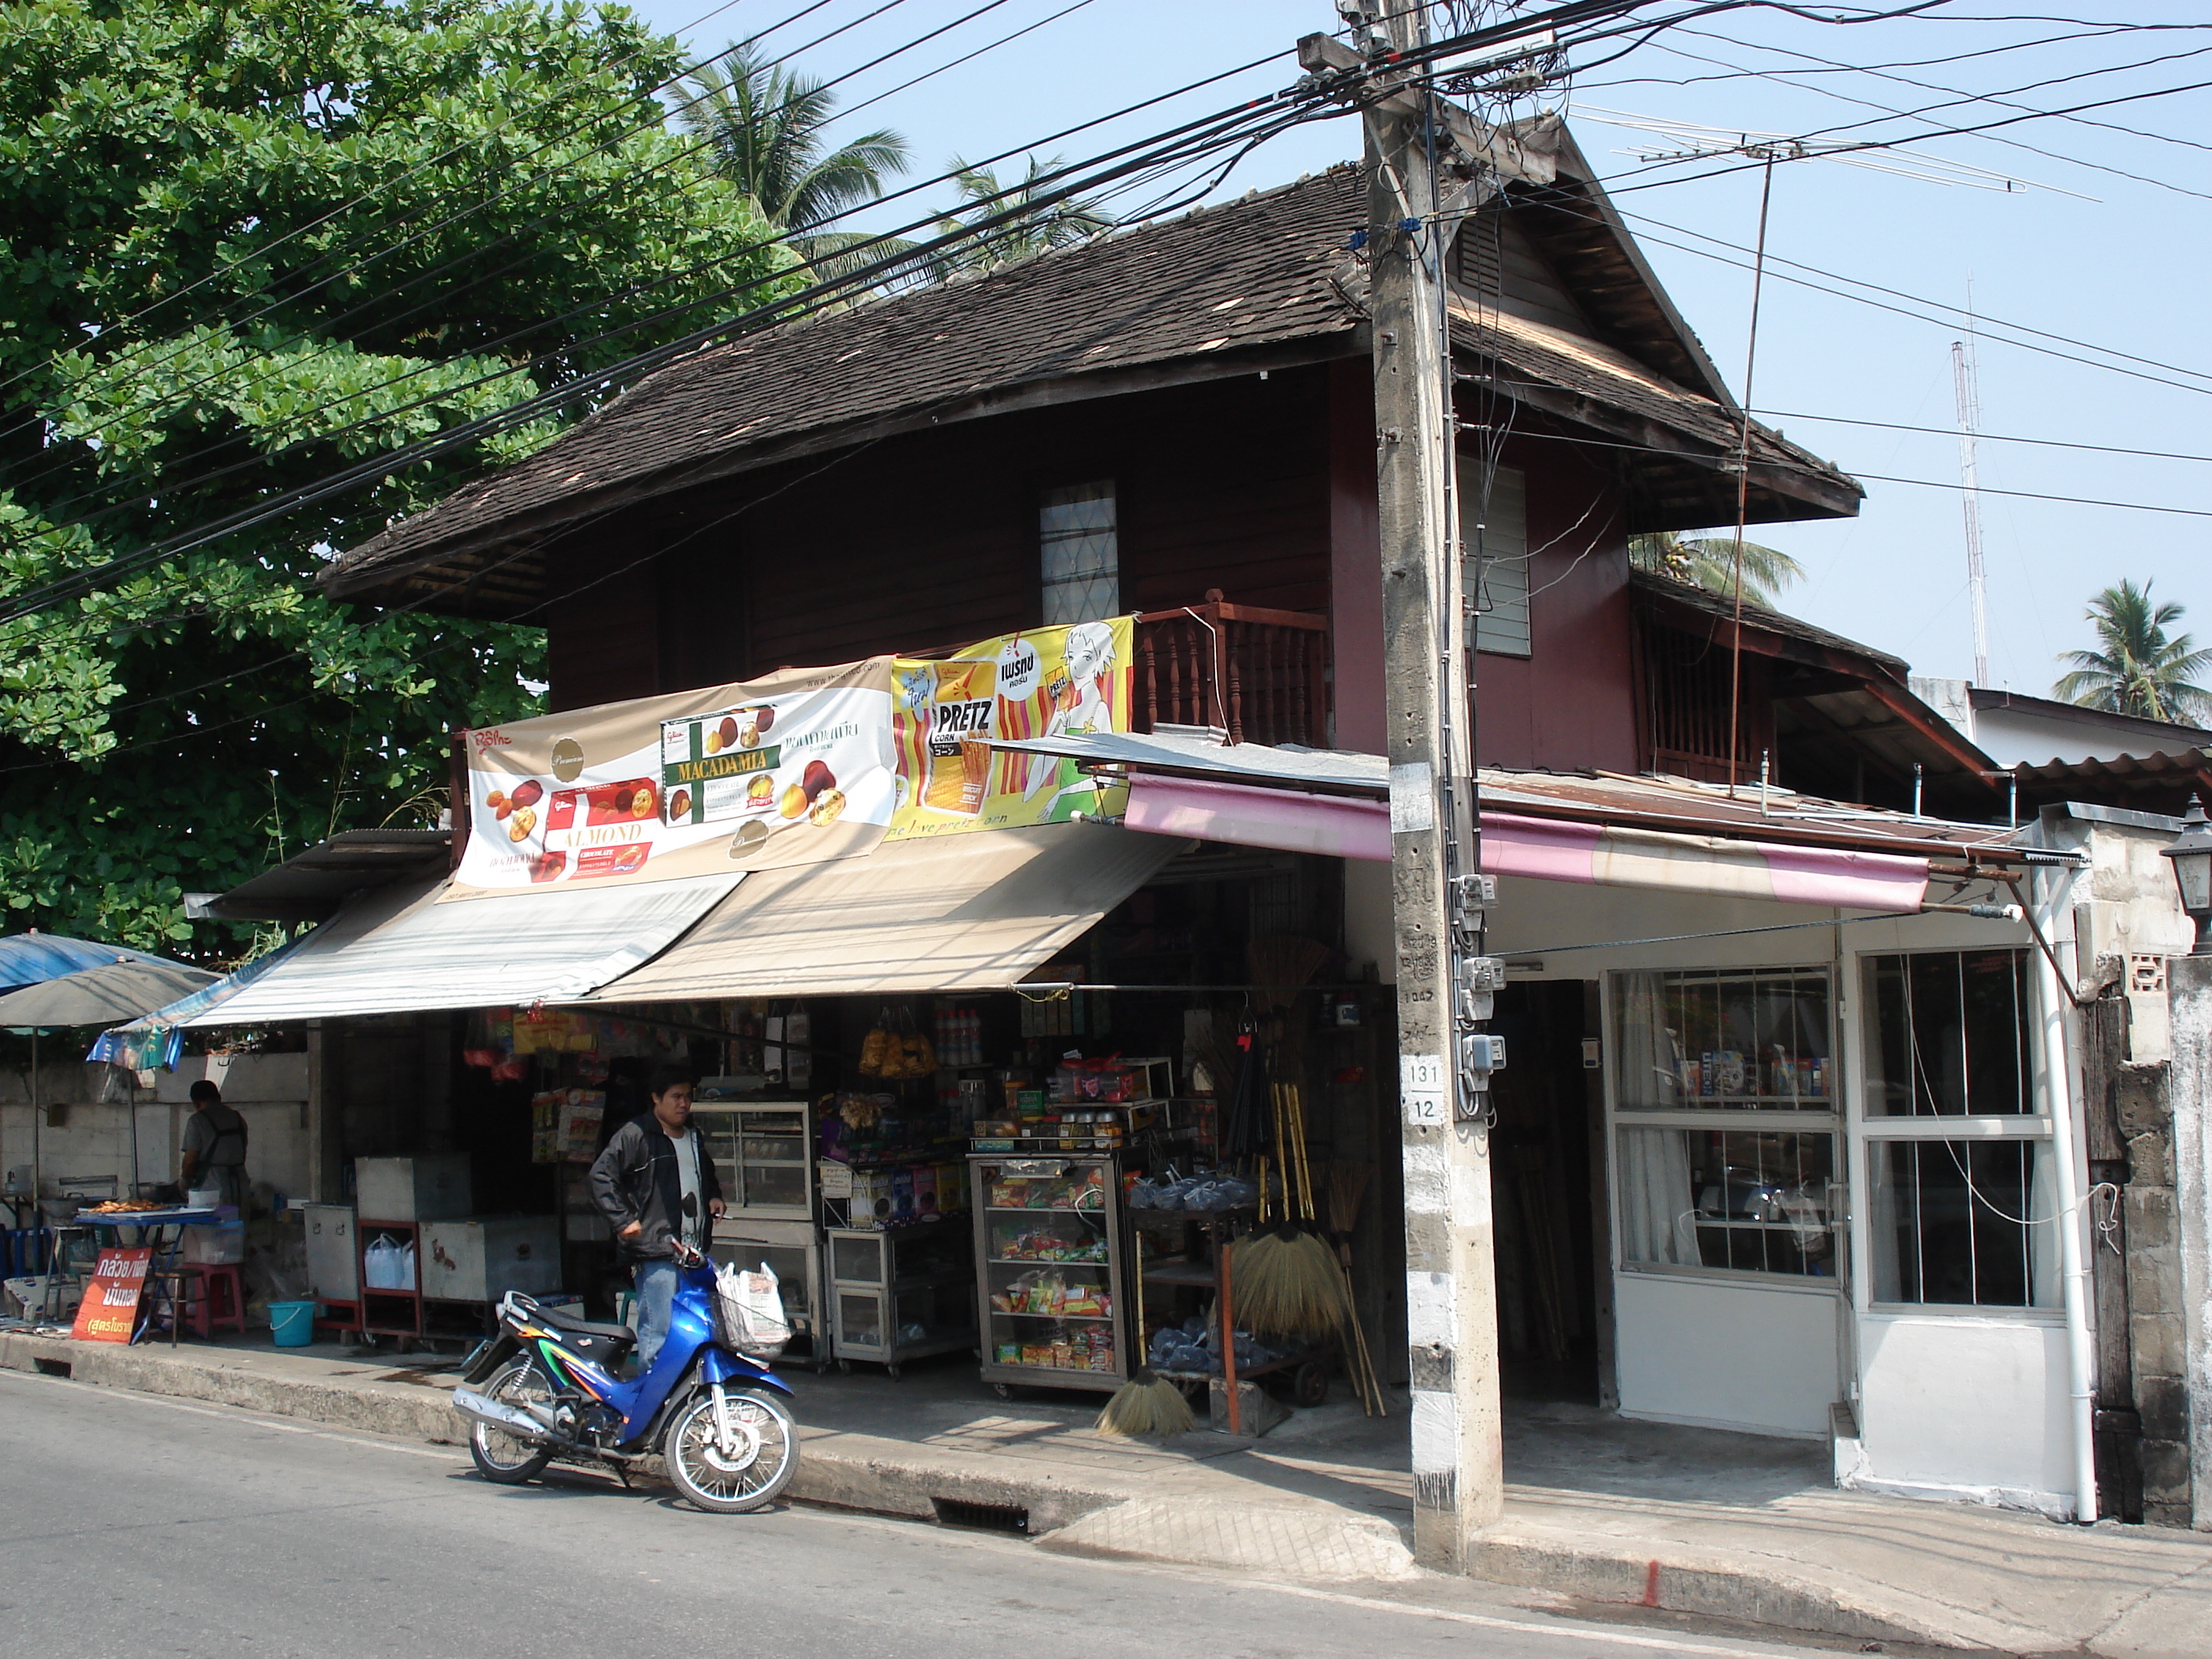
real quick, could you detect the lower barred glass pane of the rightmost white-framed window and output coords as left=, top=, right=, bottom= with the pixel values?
left=1867, top=1141, right=2057, bottom=1307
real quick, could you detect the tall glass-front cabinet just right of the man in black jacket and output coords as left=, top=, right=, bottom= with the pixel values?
left=692, top=1100, right=830, bottom=1369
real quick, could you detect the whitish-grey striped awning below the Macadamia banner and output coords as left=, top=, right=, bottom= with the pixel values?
left=174, top=872, right=743, bottom=1027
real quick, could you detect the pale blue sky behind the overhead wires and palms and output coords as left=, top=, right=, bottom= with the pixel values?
left=619, top=0, right=2212, bottom=694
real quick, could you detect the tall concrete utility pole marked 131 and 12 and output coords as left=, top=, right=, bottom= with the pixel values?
left=1301, top=0, right=1504, bottom=1570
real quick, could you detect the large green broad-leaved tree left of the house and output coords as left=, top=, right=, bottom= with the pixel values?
left=0, top=0, right=797, bottom=958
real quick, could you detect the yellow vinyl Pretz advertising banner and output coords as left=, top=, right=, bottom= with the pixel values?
left=889, top=617, right=1137, bottom=840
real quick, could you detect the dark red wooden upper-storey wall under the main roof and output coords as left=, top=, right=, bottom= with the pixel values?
left=547, top=358, right=1637, bottom=772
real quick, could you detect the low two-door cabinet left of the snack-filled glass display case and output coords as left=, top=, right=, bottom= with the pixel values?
left=827, top=1219, right=976, bottom=1376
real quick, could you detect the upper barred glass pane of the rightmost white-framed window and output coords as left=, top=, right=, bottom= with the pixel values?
left=1865, top=951, right=2035, bottom=1117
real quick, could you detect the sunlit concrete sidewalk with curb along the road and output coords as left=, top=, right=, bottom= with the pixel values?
left=0, top=1334, right=2212, bottom=1659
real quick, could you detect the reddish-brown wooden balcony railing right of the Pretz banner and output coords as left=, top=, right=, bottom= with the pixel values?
left=1133, top=588, right=1329, bottom=748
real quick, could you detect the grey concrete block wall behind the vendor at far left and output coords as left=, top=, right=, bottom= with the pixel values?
left=0, top=1053, right=309, bottom=1196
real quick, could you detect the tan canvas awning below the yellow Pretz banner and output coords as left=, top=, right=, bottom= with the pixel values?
left=579, top=823, right=1179, bottom=1004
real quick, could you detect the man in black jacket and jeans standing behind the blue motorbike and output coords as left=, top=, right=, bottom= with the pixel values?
left=591, top=1066, right=721, bottom=1372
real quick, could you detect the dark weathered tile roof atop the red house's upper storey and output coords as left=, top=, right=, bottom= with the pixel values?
left=323, top=166, right=1856, bottom=595
